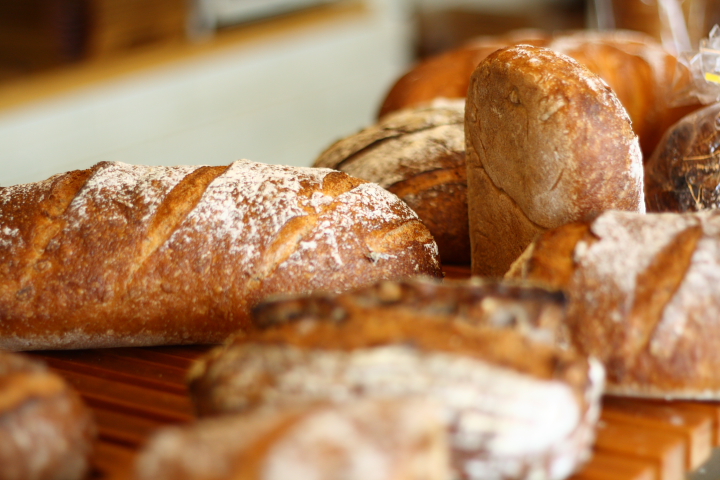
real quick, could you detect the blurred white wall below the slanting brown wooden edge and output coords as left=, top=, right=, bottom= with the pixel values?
left=0, top=0, right=410, bottom=185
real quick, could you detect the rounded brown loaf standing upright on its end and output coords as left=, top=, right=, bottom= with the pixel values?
left=465, top=45, right=645, bottom=277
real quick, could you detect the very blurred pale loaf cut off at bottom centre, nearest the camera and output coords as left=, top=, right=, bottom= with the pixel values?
left=136, top=398, right=450, bottom=480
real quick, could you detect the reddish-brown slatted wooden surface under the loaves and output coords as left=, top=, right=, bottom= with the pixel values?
left=22, top=270, right=720, bottom=480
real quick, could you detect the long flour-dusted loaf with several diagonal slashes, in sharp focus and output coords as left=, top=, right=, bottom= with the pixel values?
left=0, top=161, right=441, bottom=350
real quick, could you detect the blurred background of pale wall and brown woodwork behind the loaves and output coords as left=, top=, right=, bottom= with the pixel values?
left=0, top=0, right=716, bottom=186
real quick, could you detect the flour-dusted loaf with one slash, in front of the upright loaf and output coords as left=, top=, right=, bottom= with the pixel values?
left=508, top=211, right=720, bottom=399
